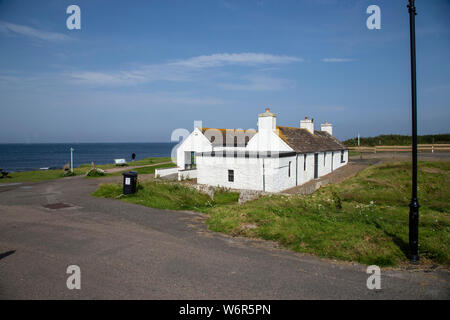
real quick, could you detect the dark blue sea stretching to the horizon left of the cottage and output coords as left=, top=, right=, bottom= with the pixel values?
left=0, top=143, right=176, bottom=172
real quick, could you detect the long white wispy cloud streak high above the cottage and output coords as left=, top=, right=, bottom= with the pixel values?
left=66, top=53, right=303, bottom=85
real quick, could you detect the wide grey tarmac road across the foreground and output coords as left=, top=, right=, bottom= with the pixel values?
left=0, top=177, right=450, bottom=299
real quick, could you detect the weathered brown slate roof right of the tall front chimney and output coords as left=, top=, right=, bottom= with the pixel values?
left=277, top=126, right=347, bottom=153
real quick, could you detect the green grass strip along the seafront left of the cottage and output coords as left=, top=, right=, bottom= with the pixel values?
left=0, top=157, right=175, bottom=183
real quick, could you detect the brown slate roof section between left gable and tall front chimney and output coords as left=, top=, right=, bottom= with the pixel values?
left=202, top=128, right=257, bottom=147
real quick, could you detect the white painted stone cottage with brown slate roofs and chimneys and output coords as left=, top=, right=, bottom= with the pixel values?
left=172, top=108, right=348, bottom=192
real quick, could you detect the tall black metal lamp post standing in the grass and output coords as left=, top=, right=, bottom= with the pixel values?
left=407, top=0, right=419, bottom=263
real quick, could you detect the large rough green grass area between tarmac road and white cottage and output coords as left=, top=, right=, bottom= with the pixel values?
left=94, top=161, right=450, bottom=266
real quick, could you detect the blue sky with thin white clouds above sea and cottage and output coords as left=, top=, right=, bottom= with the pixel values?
left=0, top=0, right=450, bottom=142
